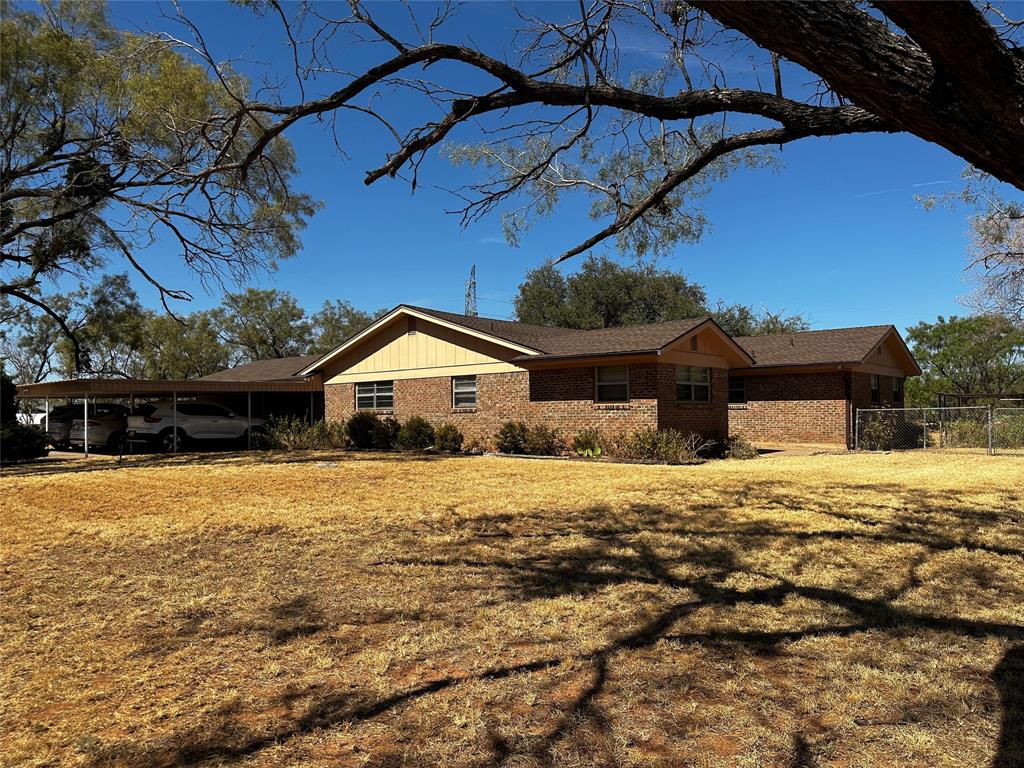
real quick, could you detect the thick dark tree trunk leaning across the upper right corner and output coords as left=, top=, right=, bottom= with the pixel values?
left=693, top=0, right=1024, bottom=189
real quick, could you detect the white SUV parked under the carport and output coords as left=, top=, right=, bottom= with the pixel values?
left=128, top=400, right=266, bottom=452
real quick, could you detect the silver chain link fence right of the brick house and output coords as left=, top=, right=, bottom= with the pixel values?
left=854, top=406, right=1024, bottom=454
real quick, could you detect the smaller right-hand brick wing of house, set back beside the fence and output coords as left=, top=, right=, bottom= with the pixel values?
left=728, top=326, right=921, bottom=447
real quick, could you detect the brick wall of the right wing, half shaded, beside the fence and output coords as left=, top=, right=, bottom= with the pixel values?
left=727, top=371, right=847, bottom=444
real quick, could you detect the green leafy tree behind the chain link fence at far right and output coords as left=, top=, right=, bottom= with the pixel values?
left=906, top=315, right=1024, bottom=406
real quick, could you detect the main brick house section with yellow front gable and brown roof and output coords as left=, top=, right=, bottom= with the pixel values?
left=299, top=305, right=754, bottom=444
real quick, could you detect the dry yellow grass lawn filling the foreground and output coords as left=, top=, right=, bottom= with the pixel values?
left=0, top=453, right=1024, bottom=768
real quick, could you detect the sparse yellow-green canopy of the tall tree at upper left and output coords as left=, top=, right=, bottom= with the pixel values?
left=0, top=0, right=315, bottom=370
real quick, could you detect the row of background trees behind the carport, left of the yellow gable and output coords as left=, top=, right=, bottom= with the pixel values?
left=0, top=274, right=382, bottom=383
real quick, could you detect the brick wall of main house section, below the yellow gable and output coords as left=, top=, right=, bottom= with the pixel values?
left=324, top=364, right=727, bottom=446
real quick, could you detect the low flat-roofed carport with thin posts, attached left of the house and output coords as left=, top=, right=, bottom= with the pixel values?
left=15, top=375, right=324, bottom=456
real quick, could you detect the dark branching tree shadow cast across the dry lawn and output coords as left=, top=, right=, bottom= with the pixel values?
left=95, top=479, right=1024, bottom=768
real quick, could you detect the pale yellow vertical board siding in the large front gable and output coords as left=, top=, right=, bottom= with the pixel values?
left=325, top=316, right=523, bottom=384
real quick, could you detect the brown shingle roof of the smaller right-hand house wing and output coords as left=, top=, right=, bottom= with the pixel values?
left=734, top=326, right=893, bottom=368
